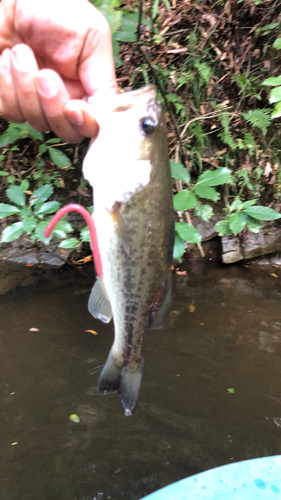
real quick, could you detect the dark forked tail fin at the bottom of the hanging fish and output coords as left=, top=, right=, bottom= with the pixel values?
left=98, top=351, right=143, bottom=417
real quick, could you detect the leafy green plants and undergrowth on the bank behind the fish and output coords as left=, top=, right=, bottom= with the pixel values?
left=0, top=0, right=281, bottom=260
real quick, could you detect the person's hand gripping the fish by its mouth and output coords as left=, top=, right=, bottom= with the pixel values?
left=0, top=0, right=117, bottom=142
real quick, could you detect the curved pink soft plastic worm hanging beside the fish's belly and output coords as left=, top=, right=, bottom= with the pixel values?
left=44, top=203, right=102, bottom=277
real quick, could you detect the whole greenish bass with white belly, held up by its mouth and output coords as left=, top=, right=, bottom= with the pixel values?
left=83, top=85, right=174, bottom=416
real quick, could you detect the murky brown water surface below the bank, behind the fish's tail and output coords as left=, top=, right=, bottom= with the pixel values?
left=0, top=267, right=281, bottom=500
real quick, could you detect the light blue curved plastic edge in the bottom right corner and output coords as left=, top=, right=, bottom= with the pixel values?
left=145, top=455, right=281, bottom=500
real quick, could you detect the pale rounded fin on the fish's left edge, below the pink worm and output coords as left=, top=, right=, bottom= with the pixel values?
left=88, top=278, right=112, bottom=323
